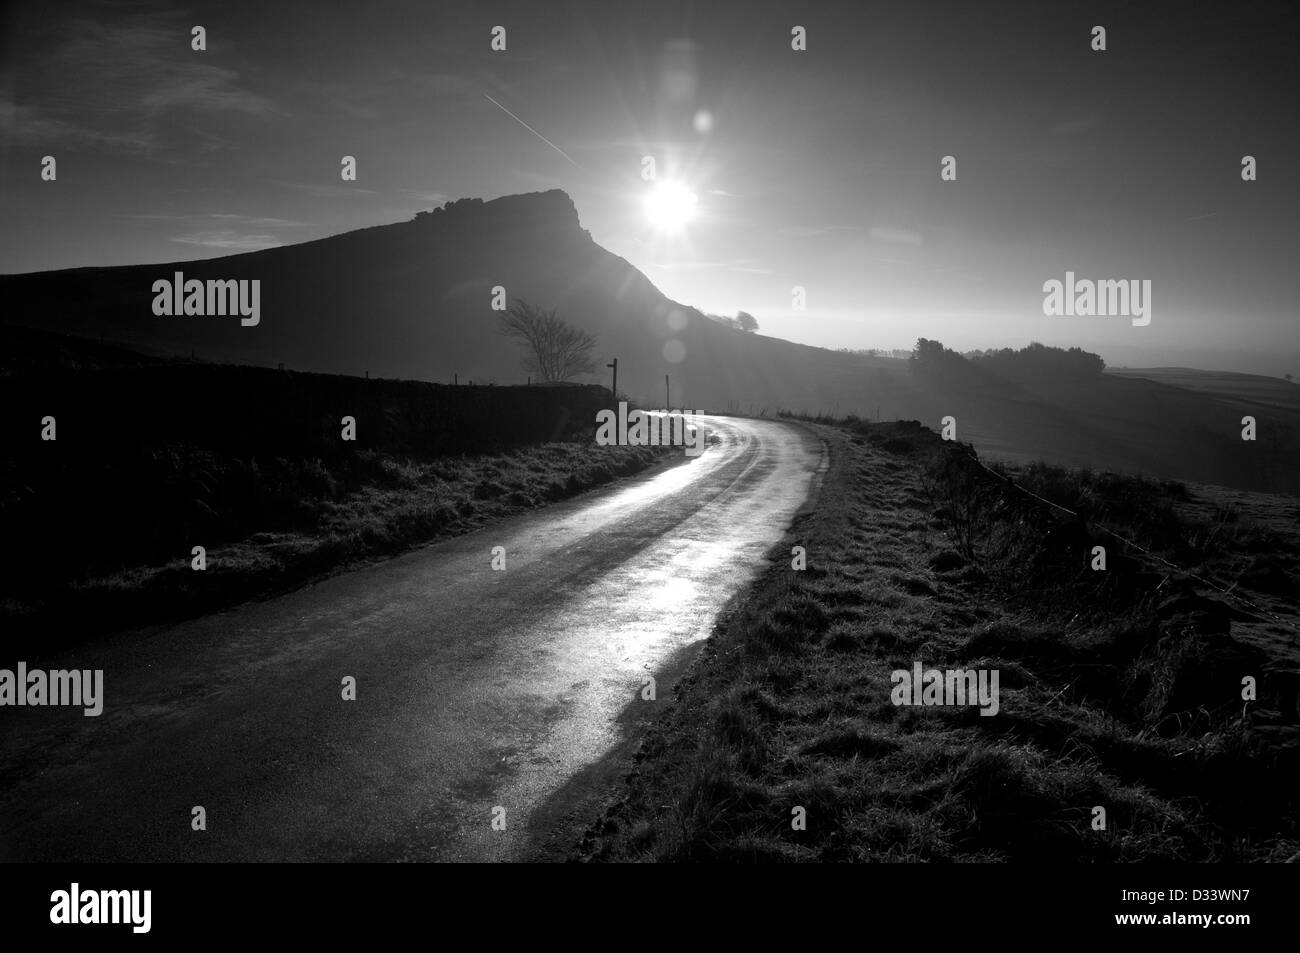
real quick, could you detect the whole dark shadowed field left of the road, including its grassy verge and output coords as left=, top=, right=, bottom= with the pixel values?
left=0, top=325, right=671, bottom=653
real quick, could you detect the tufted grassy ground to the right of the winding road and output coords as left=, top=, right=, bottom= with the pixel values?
left=575, top=421, right=1300, bottom=862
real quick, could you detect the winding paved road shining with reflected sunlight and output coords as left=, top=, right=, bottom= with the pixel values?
left=0, top=417, right=824, bottom=861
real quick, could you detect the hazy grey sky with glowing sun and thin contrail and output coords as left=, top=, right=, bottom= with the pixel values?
left=0, top=0, right=1300, bottom=374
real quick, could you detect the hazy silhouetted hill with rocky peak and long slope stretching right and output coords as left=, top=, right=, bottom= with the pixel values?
left=0, top=190, right=1300, bottom=493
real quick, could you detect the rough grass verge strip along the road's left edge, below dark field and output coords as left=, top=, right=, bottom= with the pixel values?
left=0, top=441, right=680, bottom=650
